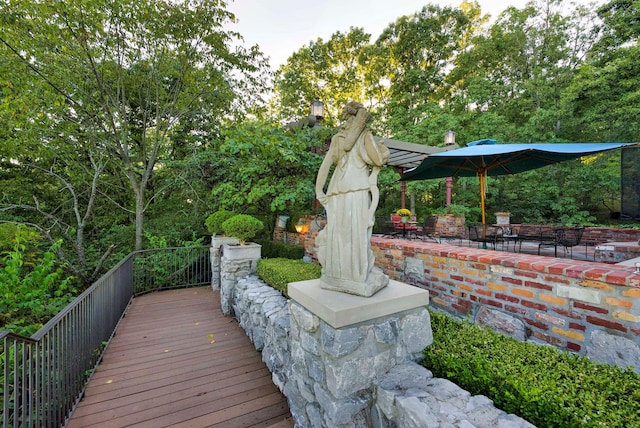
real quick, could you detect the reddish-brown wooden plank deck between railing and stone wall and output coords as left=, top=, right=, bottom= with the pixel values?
left=67, top=287, right=293, bottom=428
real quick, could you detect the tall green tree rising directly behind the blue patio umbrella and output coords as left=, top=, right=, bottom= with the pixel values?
left=453, top=0, right=593, bottom=142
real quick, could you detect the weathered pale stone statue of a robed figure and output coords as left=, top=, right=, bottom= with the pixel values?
left=316, top=102, right=389, bottom=297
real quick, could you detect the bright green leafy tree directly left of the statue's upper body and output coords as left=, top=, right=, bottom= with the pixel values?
left=212, top=123, right=331, bottom=214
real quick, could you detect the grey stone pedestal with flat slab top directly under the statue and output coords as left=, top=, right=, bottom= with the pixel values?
left=284, top=280, right=433, bottom=428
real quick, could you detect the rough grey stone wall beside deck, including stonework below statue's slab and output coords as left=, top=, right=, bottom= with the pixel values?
left=223, top=274, right=533, bottom=428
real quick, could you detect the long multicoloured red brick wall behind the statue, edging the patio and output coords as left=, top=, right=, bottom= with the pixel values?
left=294, top=232, right=640, bottom=354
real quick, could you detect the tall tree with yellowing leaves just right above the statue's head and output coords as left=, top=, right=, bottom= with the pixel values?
left=372, top=5, right=474, bottom=145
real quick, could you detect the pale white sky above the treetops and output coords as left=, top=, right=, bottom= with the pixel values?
left=227, top=0, right=526, bottom=69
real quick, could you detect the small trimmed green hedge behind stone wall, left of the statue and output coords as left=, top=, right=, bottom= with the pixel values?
left=257, top=258, right=320, bottom=296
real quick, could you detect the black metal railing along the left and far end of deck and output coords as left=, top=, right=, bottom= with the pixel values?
left=0, top=247, right=211, bottom=428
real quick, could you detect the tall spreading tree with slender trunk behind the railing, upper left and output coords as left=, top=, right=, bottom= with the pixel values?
left=0, top=0, right=266, bottom=248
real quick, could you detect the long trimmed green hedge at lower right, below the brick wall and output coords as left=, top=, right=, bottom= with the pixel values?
left=422, top=313, right=640, bottom=427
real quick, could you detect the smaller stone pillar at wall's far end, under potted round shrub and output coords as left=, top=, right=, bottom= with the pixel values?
left=220, top=242, right=262, bottom=316
